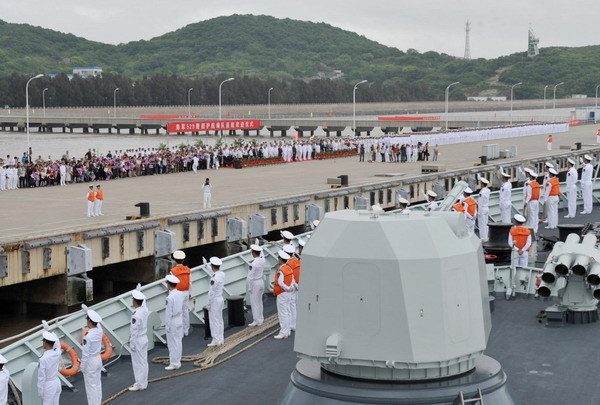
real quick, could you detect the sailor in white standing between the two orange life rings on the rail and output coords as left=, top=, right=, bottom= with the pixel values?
left=80, top=305, right=103, bottom=405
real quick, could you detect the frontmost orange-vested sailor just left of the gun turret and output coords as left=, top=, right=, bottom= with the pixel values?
left=273, top=250, right=294, bottom=339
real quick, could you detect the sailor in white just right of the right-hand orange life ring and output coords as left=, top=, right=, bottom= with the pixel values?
left=129, top=284, right=148, bottom=391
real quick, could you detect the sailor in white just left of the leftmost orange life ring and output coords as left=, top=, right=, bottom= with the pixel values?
left=38, top=331, right=62, bottom=405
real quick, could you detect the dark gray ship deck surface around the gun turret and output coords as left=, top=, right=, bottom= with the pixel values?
left=60, top=206, right=600, bottom=405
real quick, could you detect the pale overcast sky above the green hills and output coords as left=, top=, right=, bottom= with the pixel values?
left=0, top=0, right=600, bottom=58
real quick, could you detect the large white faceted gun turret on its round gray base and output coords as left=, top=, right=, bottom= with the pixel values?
left=282, top=210, right=513, bottom=405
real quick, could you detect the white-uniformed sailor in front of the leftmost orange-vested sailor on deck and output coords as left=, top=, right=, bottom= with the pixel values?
left=165, top=274, right=184, bottom=371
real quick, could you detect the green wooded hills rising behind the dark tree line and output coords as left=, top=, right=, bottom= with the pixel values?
left=0, top=15, right=600, bottom=100
